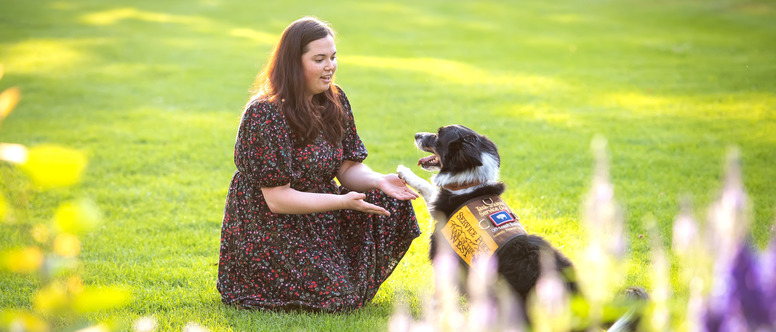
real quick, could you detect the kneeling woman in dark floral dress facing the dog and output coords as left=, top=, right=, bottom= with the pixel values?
left=217, top=17, right=420, bottom=311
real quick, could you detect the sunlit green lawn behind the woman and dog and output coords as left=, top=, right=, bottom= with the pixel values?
left=0, top=0, right=776, bottom=331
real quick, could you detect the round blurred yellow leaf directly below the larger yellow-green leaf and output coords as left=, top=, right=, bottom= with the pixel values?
left=54, top=198, right=102, bottom=235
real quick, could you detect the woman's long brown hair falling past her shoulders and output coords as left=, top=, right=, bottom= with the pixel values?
left=252, top=17, right=345, bottom=145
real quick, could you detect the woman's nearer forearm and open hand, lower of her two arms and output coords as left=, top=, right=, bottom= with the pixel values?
left=261, top=184, right=390, bottom=216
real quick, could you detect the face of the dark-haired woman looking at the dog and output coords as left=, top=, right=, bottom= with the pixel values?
left=302, top=35, right=337, bottom=98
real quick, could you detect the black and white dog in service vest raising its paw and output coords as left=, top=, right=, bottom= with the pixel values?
left=397, top=125, right=647, bottom=331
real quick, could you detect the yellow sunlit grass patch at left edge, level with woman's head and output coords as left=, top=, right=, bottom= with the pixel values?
left=3, top=39, right=87, bottom=74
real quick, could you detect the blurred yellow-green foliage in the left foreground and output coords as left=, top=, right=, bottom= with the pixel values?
left=0, top=66, right=131, bottom=331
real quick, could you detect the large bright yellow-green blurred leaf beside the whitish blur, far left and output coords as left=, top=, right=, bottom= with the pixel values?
left=20, top=145, right=86, bottom=189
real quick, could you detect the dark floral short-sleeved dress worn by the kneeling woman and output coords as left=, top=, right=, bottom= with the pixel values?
left=217, top=90, right=420, bottom=312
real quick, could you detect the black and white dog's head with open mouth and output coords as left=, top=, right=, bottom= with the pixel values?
left=415, top=125, right=501, bottom=186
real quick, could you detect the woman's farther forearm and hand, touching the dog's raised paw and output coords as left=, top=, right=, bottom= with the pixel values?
left=337, top=160, right=418, bottom=201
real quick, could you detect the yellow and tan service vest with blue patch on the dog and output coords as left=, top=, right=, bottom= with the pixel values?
left=442, top=195, right=527, bottom=266
